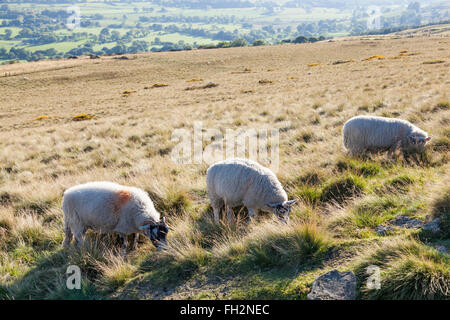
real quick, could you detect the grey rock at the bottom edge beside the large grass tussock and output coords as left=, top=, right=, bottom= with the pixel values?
left=307, top=270, right=356, bottom=300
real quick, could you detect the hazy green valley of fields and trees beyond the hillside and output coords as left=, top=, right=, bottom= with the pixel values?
left=0, top=1, right=449, bottom=62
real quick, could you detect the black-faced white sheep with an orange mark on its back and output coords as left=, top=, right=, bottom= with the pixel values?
left=62, top=182, right=169, bottom=254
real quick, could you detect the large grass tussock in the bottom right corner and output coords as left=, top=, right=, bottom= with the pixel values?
left=356, top=239, right=450, bottom=300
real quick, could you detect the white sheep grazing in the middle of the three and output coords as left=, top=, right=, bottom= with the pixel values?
left=206, top=159, right=297, bottom=222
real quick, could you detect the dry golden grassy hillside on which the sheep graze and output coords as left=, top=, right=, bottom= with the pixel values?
left=0, top=37, right=450, bottom=299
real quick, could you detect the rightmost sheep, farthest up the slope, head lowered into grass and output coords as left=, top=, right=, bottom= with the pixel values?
left=342, top=116, right=431, bottom=155
